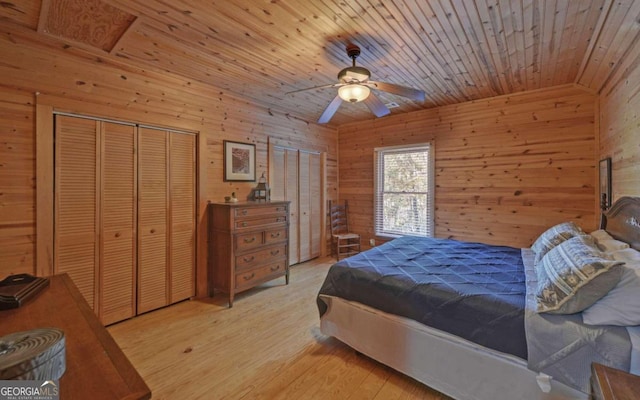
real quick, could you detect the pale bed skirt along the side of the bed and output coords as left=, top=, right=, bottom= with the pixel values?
left=320, top=295, right=589, bottom=400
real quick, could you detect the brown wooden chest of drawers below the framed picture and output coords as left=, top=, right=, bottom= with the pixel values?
left=209, top=201, right=289, bottom=307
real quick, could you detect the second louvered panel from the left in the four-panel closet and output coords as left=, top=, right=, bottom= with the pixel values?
left=98, top=122, right=137, bottom=325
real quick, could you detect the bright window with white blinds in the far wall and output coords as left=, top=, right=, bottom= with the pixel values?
left=374, top=143, right=434, bottom=237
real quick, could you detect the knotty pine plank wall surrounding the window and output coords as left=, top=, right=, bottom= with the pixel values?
left=338, top=85, right=597, bottom=247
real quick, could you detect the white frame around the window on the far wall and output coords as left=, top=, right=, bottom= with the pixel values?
left=373, top=142, right=435, bottom=238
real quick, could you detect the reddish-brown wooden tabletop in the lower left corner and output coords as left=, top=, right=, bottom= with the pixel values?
left=0, top=274, right=151, bottom=400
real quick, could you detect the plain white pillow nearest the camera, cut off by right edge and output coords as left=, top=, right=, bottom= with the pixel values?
left=582, top=248, right=640, bottom=326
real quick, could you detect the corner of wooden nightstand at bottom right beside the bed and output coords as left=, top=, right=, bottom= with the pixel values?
left=591, top=363, right=640, bottom=400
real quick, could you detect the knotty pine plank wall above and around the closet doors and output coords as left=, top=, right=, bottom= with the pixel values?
left=0, top=24, right=337, bottom=279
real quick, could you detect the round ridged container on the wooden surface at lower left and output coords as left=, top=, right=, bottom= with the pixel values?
left=0, top=328, right=66, bottom=381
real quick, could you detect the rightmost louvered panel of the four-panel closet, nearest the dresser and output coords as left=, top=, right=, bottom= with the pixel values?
left=169, top=133, right=195, bottom=303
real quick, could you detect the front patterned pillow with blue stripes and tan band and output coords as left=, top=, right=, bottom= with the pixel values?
left=536, top=236, right=624, bottom=314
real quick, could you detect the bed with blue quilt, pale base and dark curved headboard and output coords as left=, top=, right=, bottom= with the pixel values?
left=317, top=197, right=640, bottom=400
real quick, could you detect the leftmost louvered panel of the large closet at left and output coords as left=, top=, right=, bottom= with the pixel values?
left=54, top=115, right=99, bottom=309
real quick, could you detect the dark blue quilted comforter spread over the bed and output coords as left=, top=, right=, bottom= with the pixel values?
left=318, top=236, right=527, bottom=359
